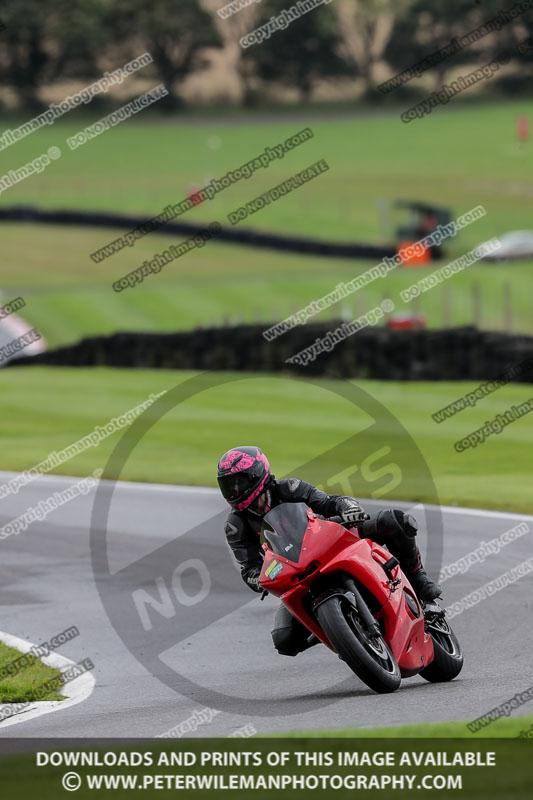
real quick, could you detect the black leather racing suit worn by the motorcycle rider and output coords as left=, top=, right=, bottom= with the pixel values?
left=225, top=478, right=418, bottom=655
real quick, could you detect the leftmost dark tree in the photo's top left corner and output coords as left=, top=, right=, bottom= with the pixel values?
left=0, top=0, right=108, bottom=107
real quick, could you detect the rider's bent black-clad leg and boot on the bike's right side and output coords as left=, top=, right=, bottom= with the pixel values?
left=359, top=508, right=441, bottom=601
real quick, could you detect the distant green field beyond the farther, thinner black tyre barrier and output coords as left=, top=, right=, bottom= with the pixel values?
left=0, top=100, right=533, bottom=239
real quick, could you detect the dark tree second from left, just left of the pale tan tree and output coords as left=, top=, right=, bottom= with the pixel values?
left=109, top=0, right=222, bottom=104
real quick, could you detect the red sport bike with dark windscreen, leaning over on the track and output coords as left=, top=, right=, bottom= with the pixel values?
left=259, top=503, right=463, bottom=692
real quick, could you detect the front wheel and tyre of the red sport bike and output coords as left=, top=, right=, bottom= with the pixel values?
left=316, top=595, right=401, bottom=694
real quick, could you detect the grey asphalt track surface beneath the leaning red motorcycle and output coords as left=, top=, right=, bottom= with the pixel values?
left=0, top=473, right=533, bottom=738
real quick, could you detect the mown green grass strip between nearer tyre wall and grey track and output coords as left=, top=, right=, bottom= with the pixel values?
left=0, top=367, right=533, bottom=512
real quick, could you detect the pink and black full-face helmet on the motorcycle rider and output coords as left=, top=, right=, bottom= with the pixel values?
left=217, top=447, right=271, bottom=511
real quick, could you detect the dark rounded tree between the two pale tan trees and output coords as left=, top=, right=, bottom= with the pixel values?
left=243, top=0, right=351, bottom=101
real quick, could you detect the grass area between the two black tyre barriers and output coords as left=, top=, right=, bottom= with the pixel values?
left=2, top=225, right=533, bottom=347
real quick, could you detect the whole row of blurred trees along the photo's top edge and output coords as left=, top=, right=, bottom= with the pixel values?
left=0, top=0, right=533, bottom=107
